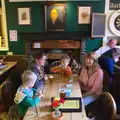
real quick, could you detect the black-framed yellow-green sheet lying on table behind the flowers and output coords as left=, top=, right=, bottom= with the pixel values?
left=51, top=97, right=82, bottom=112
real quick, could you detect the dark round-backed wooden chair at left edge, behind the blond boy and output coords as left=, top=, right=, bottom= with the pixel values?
left=0, top=80, right=14, bottom=112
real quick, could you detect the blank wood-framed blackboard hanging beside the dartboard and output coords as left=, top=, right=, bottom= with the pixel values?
left=91, top=13, right=106, bottom=38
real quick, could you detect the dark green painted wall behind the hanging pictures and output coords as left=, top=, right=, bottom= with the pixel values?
left=0, top=0, right=105, bottom=55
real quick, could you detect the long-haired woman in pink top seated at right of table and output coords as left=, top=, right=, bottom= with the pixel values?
left=79, top=53, right=103, bottom=105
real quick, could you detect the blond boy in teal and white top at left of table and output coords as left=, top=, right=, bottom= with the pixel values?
left=14, top=70, right=43, bottom=117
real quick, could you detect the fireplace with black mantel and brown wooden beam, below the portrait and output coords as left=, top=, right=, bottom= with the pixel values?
left=20, top=31, right=90, bottom=64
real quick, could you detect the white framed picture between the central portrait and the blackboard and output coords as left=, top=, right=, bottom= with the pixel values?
left=78, top=6, right=91, bottom=24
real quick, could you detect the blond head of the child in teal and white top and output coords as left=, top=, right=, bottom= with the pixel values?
left=22, top=70, right=37, bottom=85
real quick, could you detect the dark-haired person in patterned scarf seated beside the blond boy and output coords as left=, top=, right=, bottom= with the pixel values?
left=28, top=51, right=48, bottom=89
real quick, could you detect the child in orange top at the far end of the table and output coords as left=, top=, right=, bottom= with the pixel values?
left=51, top=56, right=72, bottom=77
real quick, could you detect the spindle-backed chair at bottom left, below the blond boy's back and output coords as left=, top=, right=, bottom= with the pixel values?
left=8, top=104, right=22, bottom=120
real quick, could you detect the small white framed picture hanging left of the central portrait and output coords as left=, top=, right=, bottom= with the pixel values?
left=18, top=7, right=31, bottom=25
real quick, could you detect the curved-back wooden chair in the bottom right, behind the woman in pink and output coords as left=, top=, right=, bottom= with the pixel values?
left=96, top=92, right=116, bottom=120
